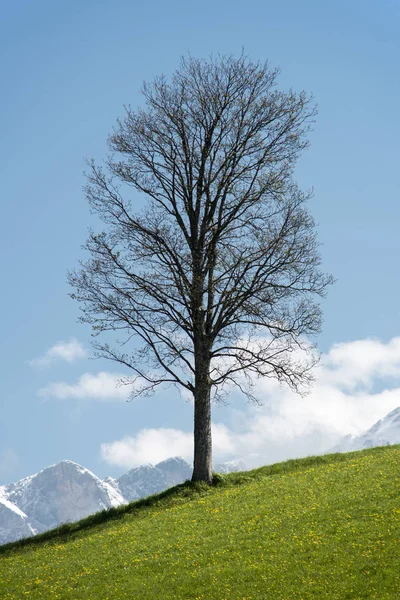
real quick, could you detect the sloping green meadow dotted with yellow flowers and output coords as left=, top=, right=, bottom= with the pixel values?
left=0, top=446, right=400, bottom=600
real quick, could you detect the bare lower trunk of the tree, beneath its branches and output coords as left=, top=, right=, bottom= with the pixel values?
left=192, top=381, right=212, bottom=483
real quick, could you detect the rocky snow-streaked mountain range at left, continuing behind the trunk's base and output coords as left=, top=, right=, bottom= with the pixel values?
left=0, top=457, right=246, bottom=544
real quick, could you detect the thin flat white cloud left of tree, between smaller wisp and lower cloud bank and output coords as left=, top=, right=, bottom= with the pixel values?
left=38, top=371, right=130, bottom=401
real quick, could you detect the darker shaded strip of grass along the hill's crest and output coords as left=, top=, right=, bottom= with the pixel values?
left=0, top=445, right=400, bottom=555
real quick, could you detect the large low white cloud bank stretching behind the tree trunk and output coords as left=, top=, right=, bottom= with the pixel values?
left=101, top=338, right=400, bottom=468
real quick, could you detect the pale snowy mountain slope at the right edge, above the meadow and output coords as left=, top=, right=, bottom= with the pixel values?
left=332, top=406, right=400, bottom=452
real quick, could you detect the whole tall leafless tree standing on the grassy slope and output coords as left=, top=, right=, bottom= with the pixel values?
left=69, top=55, right=332, bottom=482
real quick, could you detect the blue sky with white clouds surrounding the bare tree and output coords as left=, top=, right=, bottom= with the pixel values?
left=0, top=0, right=400, bottom=484
